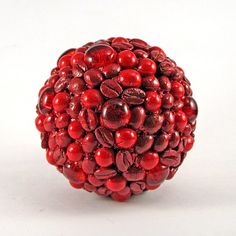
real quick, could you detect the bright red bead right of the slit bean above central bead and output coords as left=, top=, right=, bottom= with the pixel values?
left=145, top=91, right=161, bottom=112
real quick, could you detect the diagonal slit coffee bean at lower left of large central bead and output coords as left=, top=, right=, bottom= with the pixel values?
left=95, top=126, right=114, bottom=147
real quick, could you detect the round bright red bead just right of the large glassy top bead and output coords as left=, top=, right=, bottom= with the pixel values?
left=117, top=50, right=138, bottom=68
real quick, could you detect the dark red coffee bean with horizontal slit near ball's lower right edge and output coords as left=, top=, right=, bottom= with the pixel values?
left=160, top=149, right=181, bottom=167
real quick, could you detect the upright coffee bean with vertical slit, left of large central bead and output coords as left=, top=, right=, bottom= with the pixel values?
left=79, top=109, right=98, bottom=131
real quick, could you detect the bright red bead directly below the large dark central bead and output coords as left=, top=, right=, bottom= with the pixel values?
left=115, top=128, right=137, bottom=148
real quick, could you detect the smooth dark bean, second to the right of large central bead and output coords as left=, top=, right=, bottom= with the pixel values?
left=143, top=114, right=164, bottom=134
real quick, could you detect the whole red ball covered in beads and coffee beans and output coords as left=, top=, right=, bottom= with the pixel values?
left=35, top=37, right=198, bottom=201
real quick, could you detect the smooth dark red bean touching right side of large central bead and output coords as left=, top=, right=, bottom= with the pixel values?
left=129, top=106, right=146, bottom=129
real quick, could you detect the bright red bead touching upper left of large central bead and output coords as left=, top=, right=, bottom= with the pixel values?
left=80, top=89, right=103, bottom=108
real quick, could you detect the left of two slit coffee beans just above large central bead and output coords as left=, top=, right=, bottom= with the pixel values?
left=100, top=79, right=123, bottom=98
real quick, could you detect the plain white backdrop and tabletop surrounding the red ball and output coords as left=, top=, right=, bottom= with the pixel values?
left=0, top=0, right=236, bottom=236
